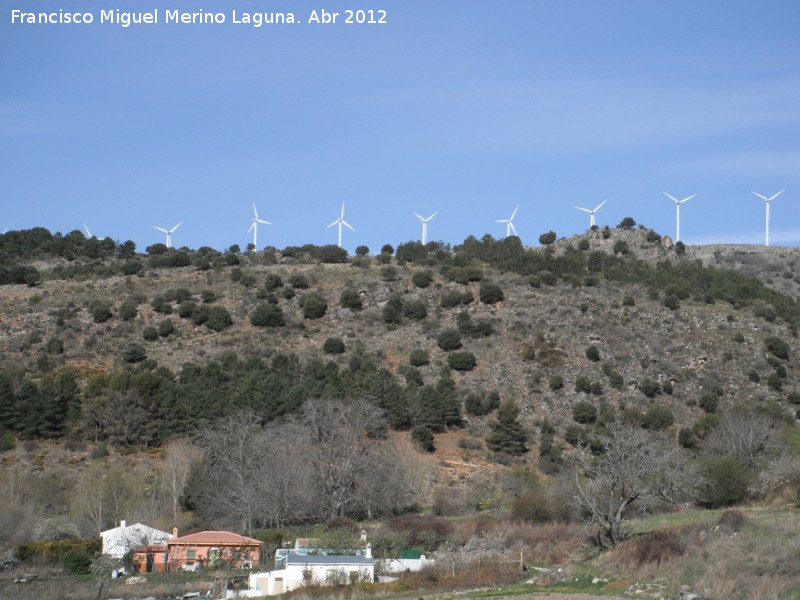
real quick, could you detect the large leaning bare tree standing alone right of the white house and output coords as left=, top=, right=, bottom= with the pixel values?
left=574, top=423, right=701, bottom=547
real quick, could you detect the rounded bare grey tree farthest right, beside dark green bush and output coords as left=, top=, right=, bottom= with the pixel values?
left=706, top=408, right=783, bottom=469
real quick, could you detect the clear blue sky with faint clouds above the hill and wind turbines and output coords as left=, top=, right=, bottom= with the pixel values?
left=0, top=0, right=800, bottom=252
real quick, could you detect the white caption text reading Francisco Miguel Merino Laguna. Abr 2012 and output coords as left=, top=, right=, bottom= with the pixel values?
left=11, top=8, right=387, bottom=27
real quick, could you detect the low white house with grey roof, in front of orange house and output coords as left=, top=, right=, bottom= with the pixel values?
left=248, top=552, right=375, bottom=596
